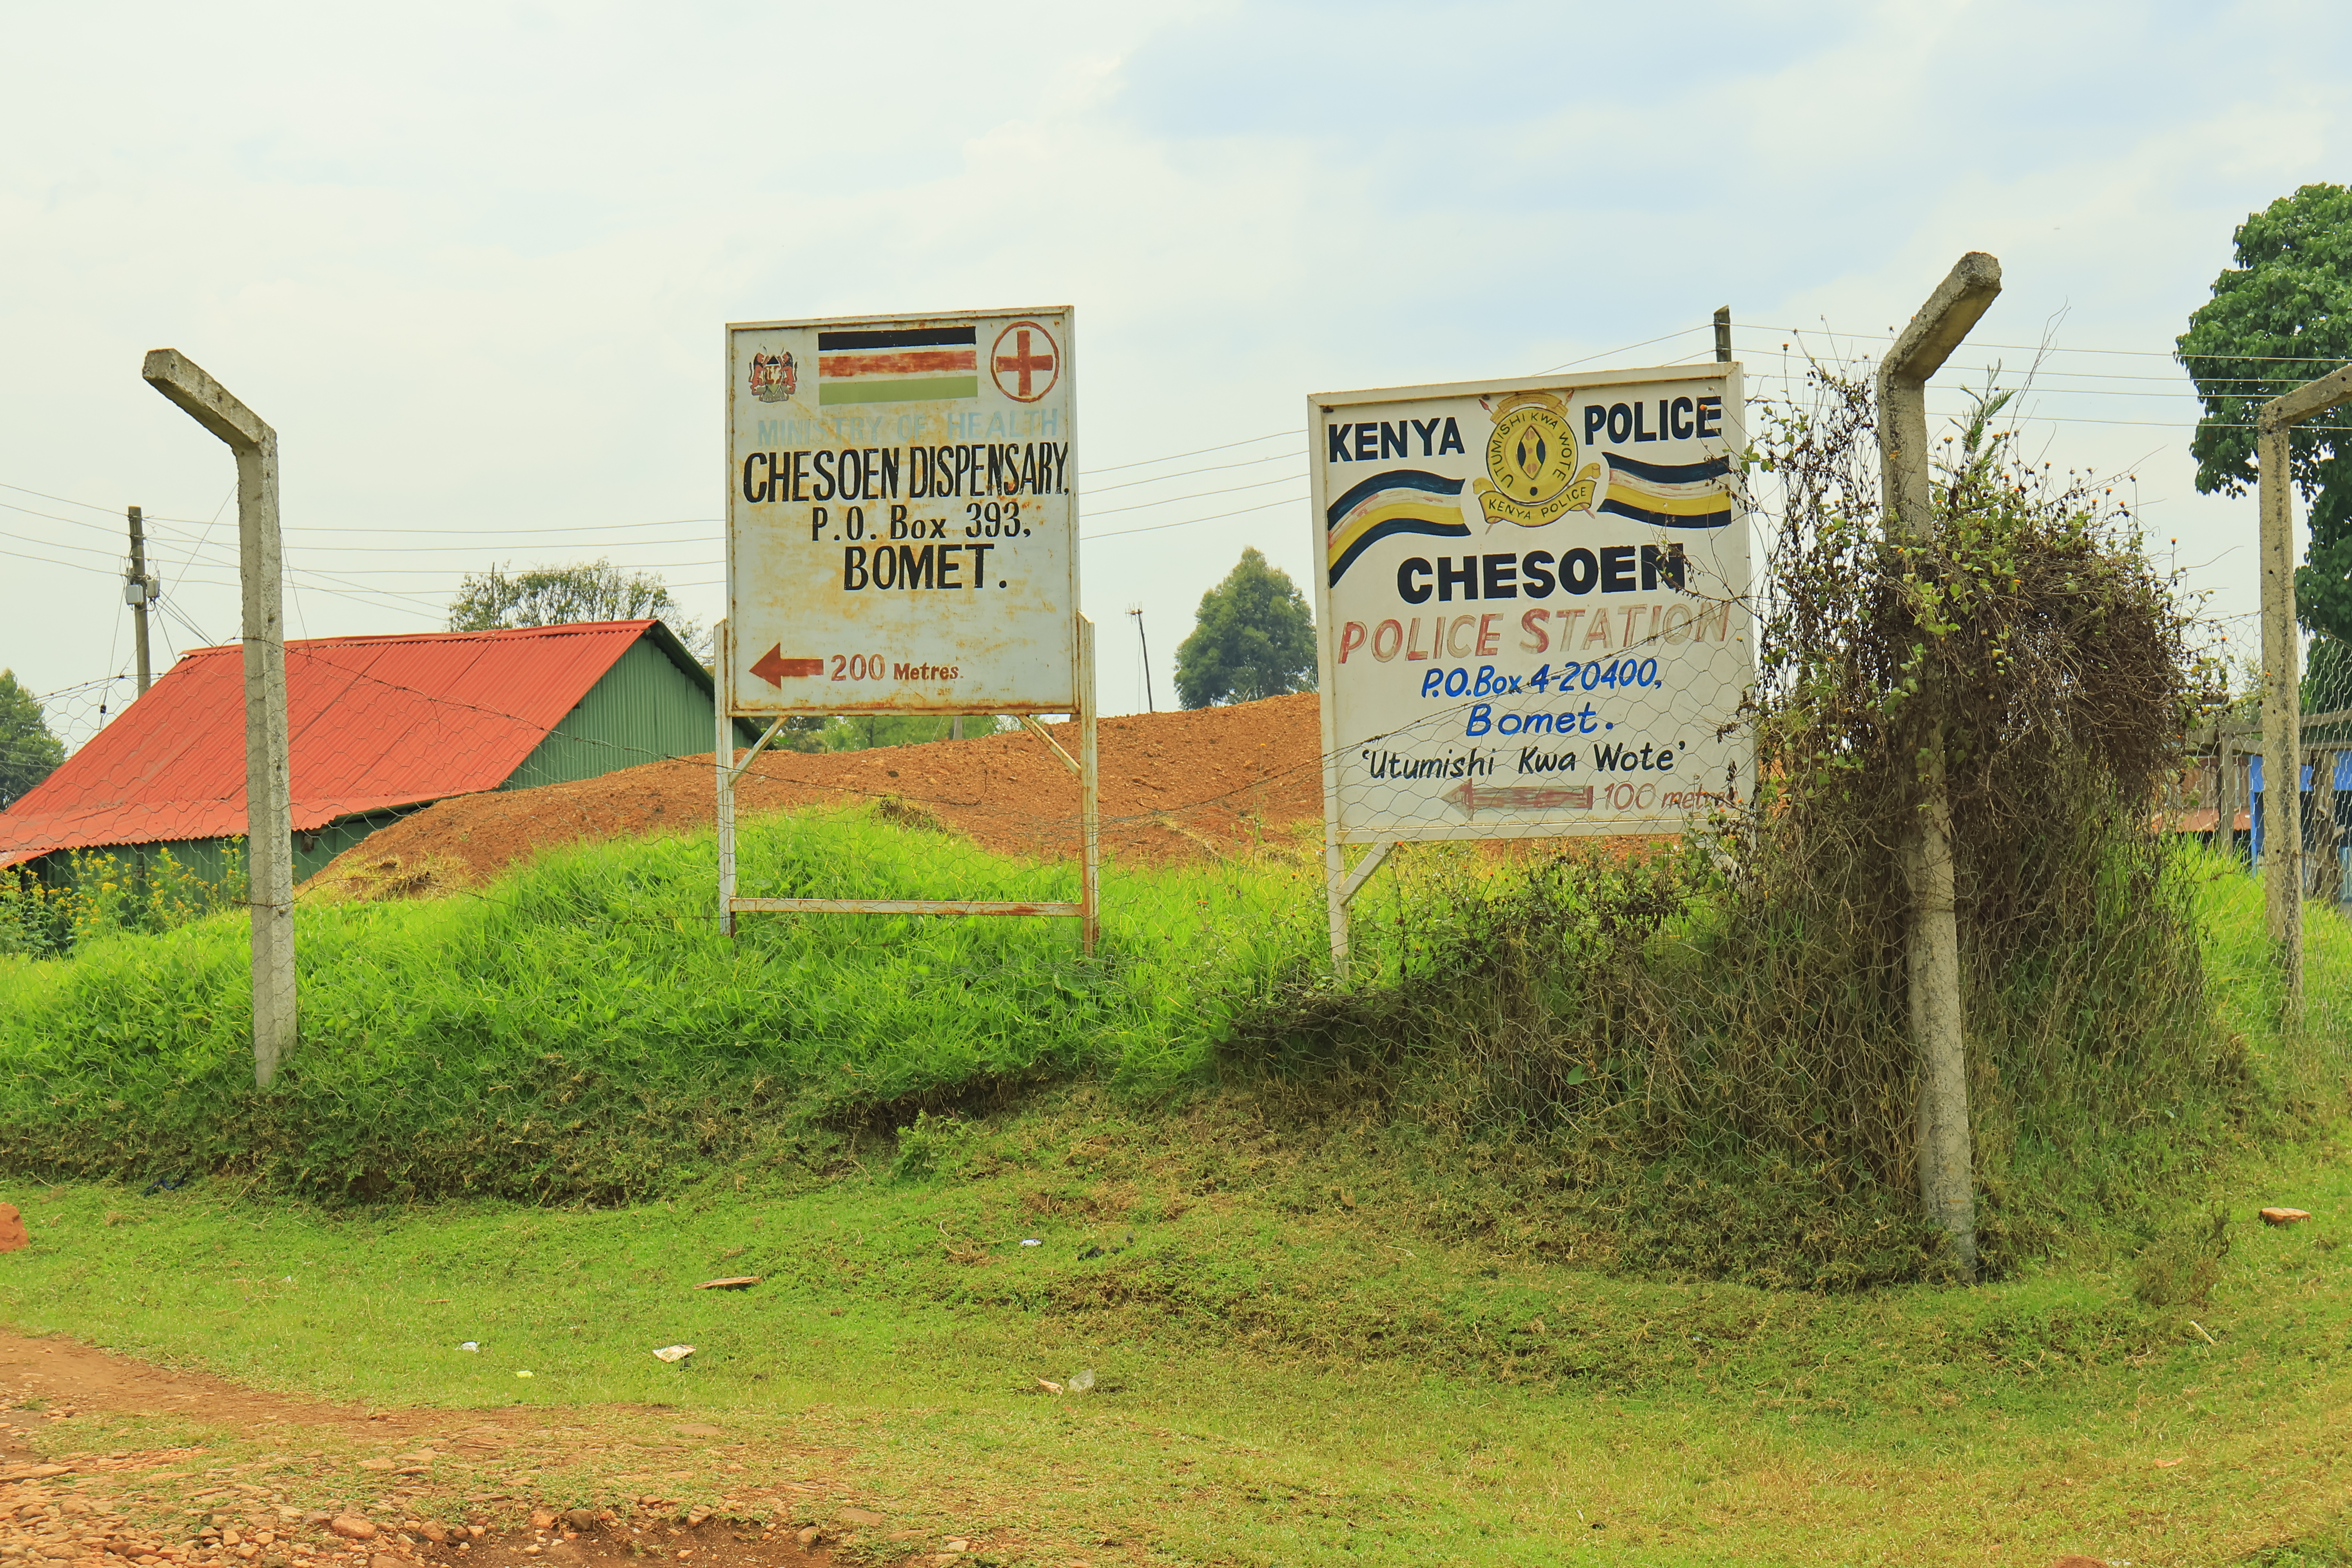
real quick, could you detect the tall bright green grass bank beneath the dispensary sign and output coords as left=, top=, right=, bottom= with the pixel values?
left=0, top=813, right=1319, bottom=1199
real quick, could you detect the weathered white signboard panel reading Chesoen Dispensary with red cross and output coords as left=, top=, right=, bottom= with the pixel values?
left=727, top=306, right=1077, bottom=715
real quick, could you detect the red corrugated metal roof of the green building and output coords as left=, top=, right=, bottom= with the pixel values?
left=0, top=621, right=682, bottom=865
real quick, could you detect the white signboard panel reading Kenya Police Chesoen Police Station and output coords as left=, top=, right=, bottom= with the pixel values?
left=1308, top=365, right=1755, bottom=844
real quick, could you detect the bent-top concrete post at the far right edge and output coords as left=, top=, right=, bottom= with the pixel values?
left=2253, top=367, right=2352, bottom=1027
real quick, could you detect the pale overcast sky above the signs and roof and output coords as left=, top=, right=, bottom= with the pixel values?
left=0, top=0, right=2352, bottom=740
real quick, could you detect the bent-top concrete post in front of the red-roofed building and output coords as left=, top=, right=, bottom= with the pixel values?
left=139, top=348, right=294, bottom=1089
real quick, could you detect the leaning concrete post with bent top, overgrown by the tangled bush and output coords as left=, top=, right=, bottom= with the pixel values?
left=1879, top=252, right=2002, bottom=1279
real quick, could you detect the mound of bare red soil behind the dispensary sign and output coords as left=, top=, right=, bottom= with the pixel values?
left=310, top=691, right=1322, bottom=893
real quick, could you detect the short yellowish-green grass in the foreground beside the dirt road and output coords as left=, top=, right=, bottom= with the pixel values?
left=14, top=1091, right=2352, bottom=1563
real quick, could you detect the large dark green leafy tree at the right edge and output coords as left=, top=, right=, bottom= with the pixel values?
left=2176, top=186, right=2352, bottom=701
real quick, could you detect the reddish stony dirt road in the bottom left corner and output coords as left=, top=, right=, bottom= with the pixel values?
left=0, top=1335, right=1025, bottom=1568
